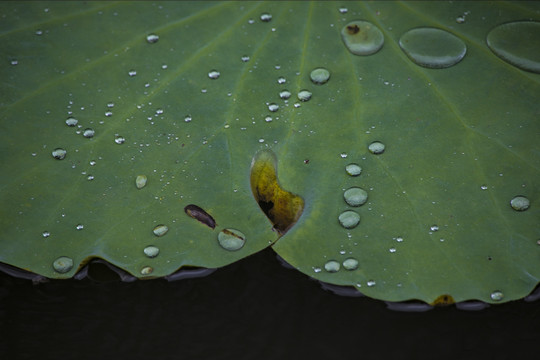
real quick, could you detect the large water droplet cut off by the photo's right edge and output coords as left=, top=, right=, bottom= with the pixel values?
left=486, top=21, right=540, bottom=73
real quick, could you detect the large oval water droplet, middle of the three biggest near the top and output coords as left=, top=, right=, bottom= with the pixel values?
left=399, top=27, right=467, bottom=69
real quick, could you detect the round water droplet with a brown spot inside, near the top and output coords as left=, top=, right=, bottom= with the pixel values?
left=341, top=21, right=384, bottom=55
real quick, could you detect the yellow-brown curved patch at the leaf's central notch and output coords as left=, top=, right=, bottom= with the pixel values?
left=250, top=150, right=304, bottom=235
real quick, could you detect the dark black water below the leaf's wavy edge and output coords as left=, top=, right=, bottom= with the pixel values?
left=0, top=249, right=540, bottom=360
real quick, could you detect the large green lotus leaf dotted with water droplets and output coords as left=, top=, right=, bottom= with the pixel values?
left=0, top=2, right=540, bottom=303
